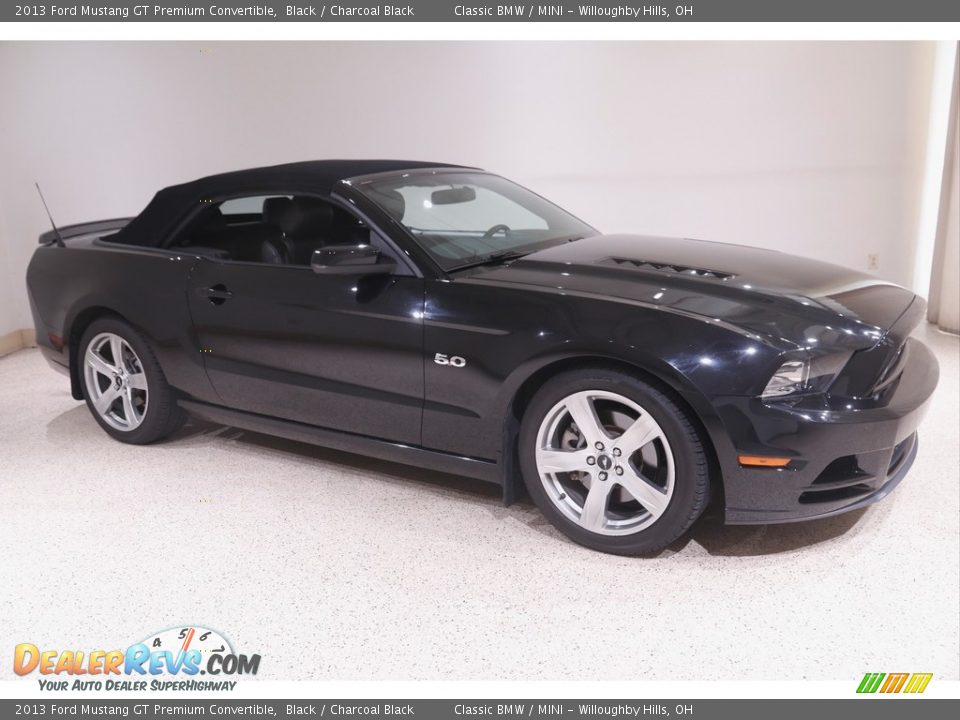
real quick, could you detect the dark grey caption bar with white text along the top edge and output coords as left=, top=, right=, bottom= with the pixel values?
left=0, top=0, right=960, bottom=22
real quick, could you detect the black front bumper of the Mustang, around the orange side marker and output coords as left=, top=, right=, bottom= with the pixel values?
left=717, top=338, right=939, bottom=524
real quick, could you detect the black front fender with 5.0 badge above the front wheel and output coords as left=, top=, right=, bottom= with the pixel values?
left=423, top=282, right=768, bottom=472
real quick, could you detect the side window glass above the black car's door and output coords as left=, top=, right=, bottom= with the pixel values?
left=173, top=194, right=403, bottom=267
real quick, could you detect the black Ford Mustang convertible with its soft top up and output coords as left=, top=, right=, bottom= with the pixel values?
left=27, top=160, right=938, bottom=555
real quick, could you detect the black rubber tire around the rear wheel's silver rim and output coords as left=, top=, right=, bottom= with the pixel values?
left=77, top=317, right=186, bottom=445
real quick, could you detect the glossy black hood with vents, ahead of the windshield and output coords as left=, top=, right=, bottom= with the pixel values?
left=465, top=235, right=915, bottom=350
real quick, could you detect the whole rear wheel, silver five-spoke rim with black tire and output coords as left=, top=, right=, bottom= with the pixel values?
left=77, top=318, right=183, bottom=445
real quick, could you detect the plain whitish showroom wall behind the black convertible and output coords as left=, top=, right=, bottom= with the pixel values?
left=0, top=42, right=933, bottom=335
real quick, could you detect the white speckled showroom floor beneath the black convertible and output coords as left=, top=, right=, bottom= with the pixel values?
left=0, top=330, right=960, bottom=680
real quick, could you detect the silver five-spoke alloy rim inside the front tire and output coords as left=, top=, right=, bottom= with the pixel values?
left=537, top=390, right=675, bottom=535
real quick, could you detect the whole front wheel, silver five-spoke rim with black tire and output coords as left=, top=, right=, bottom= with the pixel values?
left=520, top=369, right=710, bottom=555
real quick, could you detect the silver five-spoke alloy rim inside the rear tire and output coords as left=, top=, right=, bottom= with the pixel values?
left=83, top=333, right=149, bottom=432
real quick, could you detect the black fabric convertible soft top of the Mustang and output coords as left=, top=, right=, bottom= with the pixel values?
left=111, top=160, right=463, bottom=247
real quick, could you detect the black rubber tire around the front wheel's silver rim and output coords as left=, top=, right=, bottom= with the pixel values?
left=519, top=368, right=710, bottom=556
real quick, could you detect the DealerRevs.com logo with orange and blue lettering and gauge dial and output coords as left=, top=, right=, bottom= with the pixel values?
left=13, top=626, right=260, bottom=690
